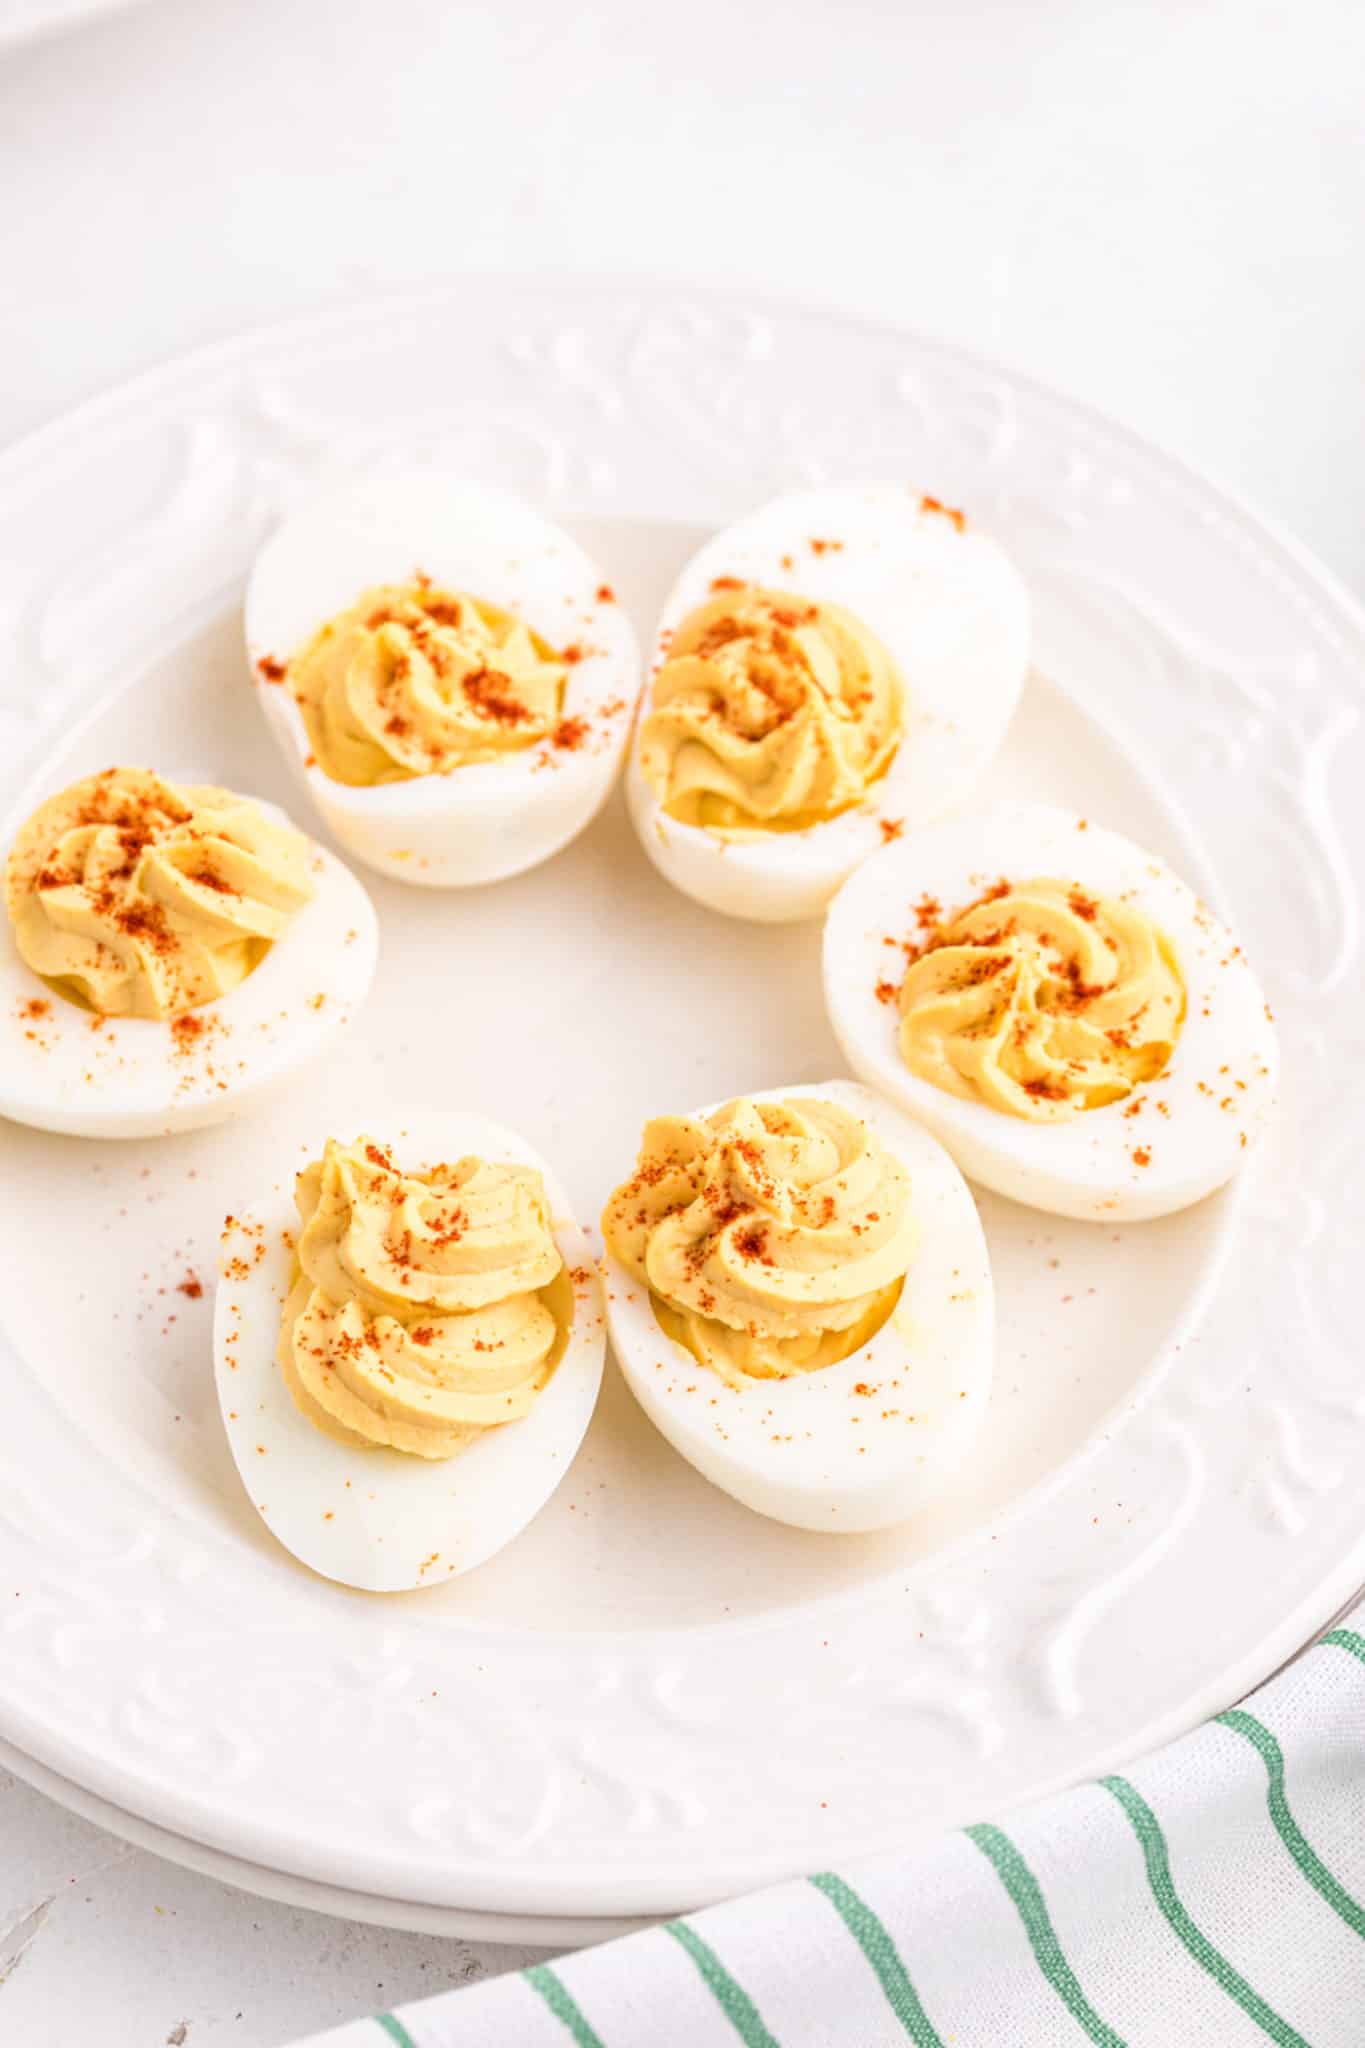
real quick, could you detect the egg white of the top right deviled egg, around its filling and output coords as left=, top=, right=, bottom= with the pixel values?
left=626, top=483, right=1029, bottom=922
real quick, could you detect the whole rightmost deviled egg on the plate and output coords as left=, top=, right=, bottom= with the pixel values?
left=825, top=803, right=1279, bottom=1221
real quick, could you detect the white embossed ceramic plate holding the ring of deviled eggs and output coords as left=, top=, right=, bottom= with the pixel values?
left=0, top=283, right=1365, bottom=1933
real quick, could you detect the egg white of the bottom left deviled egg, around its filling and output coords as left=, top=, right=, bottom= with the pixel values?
left=213, top=1108, right=606, bottom=1593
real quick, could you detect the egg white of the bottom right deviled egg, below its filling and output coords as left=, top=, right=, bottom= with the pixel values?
left=606, top=1081, right=995, bottom=1532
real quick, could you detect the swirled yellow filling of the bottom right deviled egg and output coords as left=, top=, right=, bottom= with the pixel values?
left=602, top=1096, right=915, bottom=1386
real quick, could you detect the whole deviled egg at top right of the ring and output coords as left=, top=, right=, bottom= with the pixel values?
left=626, top=483, right=1029, bottom=922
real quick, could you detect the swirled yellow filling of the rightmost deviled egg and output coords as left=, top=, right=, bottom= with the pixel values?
left=898, top=879, right=1185, bottom=1122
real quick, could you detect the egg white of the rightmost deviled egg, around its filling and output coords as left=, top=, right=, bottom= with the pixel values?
left=825, top=805, right=1279, bottom=1221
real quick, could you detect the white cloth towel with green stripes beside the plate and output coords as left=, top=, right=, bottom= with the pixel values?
left=296, top=1608, right=1365, bottom=2048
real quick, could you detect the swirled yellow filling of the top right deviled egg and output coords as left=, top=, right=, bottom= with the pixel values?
left=641, top=584, right=905, bottom=834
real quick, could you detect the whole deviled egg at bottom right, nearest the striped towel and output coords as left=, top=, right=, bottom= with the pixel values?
left=602, top=1081, right=995, bottom=1532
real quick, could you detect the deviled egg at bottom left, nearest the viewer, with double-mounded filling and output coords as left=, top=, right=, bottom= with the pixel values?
left=213, top=1110, right=606, bottom=1591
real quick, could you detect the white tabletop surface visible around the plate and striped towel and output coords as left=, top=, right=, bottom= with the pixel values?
left=0, top=0, right=1365, bottom=2048
